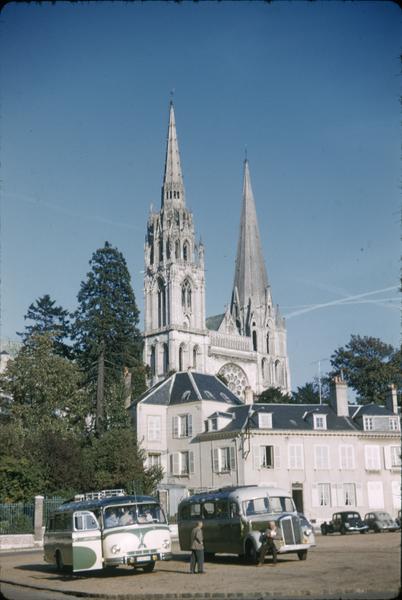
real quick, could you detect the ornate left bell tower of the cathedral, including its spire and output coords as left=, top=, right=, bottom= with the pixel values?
left=144, top=102, right=208, bottom=385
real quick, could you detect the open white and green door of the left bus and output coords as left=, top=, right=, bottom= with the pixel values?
left=72, top=510, right=103, bottom=572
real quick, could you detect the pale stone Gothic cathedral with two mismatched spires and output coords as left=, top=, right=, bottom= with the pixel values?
left=144, top=103, right=290, bottom=399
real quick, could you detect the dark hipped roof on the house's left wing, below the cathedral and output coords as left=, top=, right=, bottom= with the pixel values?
left=136, top=371, right=243, bottom=406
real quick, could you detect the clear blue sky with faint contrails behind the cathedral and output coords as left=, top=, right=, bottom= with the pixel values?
left=0, top=2, right=402, bottom=389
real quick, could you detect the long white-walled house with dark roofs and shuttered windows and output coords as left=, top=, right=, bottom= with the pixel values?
left=130, top=371, right=401, bottom=523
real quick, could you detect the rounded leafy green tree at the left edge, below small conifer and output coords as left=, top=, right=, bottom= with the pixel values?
left=0, top=333, right=88, bottom=431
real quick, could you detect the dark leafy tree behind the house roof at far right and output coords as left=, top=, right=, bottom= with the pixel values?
left=330, top=335, right=402, bottom=404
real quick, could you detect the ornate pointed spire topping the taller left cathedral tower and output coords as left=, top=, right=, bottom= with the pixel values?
left=161, top=101, right=185, bottom=208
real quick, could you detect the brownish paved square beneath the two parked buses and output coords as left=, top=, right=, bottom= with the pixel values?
left=0, top=533, right=401, bottom=600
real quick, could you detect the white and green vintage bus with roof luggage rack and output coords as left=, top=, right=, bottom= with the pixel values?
left=44, top=490, right=172, bottom=572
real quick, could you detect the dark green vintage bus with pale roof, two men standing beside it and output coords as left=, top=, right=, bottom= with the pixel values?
left=178, top=485, right=314, bottom=563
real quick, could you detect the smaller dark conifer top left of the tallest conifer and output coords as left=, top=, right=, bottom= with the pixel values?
left=18, top=294, right=71, bottom=358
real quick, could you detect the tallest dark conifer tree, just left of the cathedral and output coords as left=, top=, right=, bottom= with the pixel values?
left=72, top=242, right=145, bottom=433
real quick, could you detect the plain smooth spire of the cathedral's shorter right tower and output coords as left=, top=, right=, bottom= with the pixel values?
left=232, top=159, right=269, bottom=335
